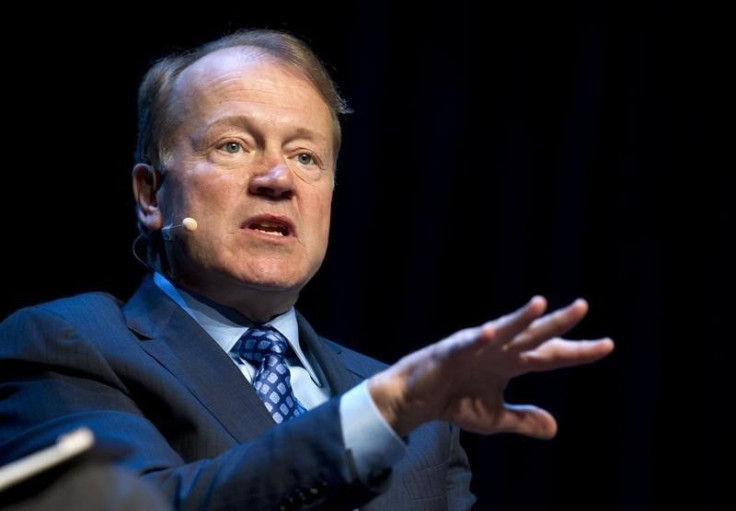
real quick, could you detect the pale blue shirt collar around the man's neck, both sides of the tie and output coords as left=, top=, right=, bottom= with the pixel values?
left=153, top=273, right=321, bottom=386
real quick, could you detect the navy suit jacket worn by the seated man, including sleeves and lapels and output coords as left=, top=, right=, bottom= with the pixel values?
left=0, top=277, right=474, bottom=511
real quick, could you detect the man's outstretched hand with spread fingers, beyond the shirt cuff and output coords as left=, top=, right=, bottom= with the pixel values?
left=368, top=296, right=613, bottom=438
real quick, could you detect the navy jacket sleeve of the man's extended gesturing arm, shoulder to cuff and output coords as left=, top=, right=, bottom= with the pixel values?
left=0, top=307, right=386, bottom=511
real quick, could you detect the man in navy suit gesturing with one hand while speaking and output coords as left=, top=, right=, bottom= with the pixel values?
left=0, top=31, right=613, bottom=510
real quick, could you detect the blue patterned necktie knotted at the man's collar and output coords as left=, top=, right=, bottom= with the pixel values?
left=232, top=325, right=307, bottom=424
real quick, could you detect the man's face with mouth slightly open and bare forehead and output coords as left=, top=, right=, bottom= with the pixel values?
left=158, top=48, right=335, bottom=302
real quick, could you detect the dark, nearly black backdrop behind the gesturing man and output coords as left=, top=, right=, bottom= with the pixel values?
left=0, top=0, right=734, bottom=511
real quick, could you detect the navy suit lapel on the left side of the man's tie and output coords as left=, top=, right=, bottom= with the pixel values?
left=123, top=276, right=274, bottom=443
